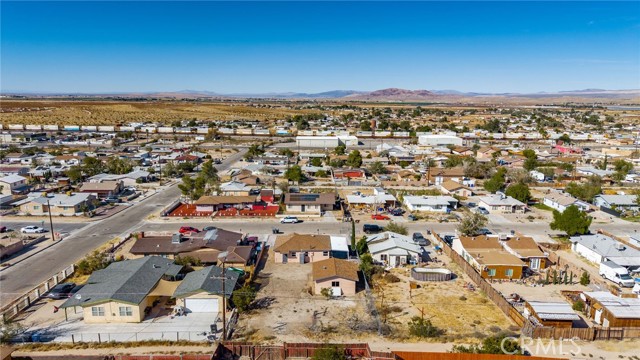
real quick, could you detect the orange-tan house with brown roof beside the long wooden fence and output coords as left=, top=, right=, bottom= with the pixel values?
left=451, top=235, right=526, bottom=280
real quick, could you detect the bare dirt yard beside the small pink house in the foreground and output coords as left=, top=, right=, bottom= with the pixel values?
left=234, top=251, right=376, bottom=342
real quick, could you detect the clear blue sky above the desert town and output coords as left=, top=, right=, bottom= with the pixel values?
left=0, top=1, right=640, bottom=93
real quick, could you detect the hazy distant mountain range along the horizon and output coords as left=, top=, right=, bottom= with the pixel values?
left=2, top=88, right=640, bottom=102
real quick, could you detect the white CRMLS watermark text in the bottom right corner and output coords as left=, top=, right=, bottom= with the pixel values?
left=500, top=336, right=582, bottom=356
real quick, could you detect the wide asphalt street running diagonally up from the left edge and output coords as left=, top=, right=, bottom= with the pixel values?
left=0, top=150, right=246, bottom=305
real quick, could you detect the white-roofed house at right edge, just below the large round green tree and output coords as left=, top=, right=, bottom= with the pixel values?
left=569, top=234, right=640, bottom=269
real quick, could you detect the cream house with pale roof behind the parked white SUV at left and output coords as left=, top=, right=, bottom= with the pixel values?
left=19, top=193, right=95, bottom=216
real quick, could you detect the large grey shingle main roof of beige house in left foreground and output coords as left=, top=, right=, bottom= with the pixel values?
left=61, top=256, right=182, bottom=307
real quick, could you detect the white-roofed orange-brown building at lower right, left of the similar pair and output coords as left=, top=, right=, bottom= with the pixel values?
left=524, top=301, right=581, bottom=328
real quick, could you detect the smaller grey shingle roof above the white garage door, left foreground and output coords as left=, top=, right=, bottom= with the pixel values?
left=173, top=266, right=239, bottom=298
